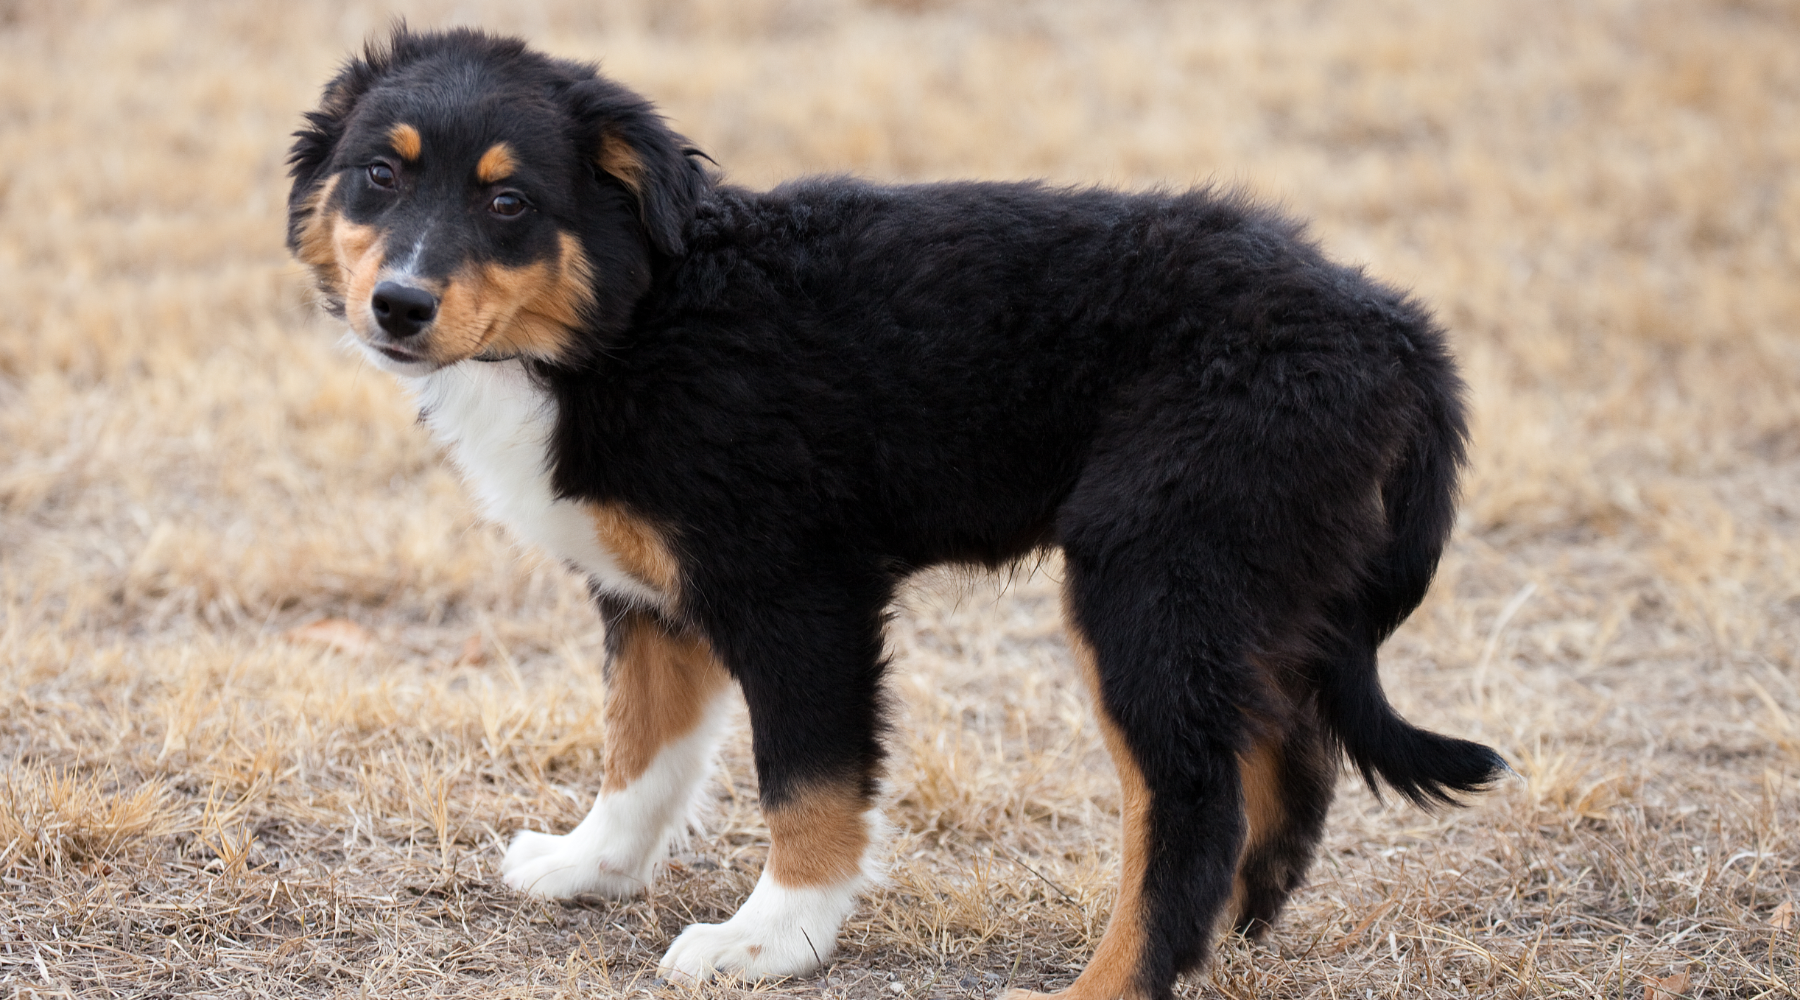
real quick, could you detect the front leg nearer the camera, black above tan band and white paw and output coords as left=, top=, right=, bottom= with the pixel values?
left=659, top=593, right=882, bottom=982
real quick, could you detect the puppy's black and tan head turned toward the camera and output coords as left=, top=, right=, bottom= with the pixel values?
left=288, top=27, right=709, bottom=374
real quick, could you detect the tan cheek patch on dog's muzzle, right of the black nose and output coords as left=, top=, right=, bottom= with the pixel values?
left=430, top=232, right=594, bottom=365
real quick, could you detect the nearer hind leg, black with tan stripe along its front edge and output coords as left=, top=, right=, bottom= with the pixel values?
left=1008, top=545, right=1262, bottom=1000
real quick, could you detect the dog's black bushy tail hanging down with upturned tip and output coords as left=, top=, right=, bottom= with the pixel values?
left=1318, top=343, right=1510, bottom=806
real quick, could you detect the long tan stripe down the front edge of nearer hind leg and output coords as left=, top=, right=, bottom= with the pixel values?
left=1010, top=607, right=1150, bottom=1000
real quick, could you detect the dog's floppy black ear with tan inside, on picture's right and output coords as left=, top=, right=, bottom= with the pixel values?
left=567, top=77, right=711, bottom=254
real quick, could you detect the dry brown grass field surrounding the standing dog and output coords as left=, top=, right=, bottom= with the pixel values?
left=0, top=0, right=1800, bottom=1000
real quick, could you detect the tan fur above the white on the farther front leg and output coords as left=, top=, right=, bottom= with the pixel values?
left=601, top=613, right=731, bottom=793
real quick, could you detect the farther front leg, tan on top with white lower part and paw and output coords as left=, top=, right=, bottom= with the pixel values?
left=500, top=601, right=733, bottom=899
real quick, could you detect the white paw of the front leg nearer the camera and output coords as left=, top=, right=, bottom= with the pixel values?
left=657, top=872, right=864, bottom=984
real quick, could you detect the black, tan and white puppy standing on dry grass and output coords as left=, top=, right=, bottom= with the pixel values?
left=288, top=25, right=1507, bottom=1000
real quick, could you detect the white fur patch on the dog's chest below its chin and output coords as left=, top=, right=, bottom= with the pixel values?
left=400, top=362, right=664, bottom=606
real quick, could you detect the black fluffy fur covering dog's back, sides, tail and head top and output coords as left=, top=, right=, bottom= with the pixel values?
left=293, top=32, right=1503, bottom=995
